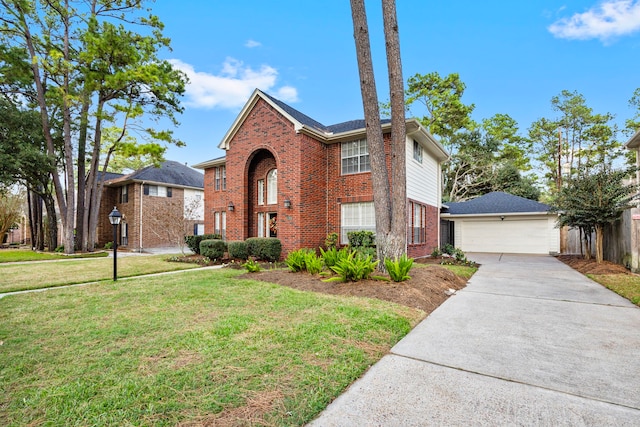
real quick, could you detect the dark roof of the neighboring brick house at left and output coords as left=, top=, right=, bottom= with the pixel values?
left=106, top=160, right=204, bottom=189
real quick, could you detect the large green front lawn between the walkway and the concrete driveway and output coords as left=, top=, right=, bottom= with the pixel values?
left=0, top=268, right=424, bottom=426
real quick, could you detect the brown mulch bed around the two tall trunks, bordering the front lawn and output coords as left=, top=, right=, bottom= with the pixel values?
left=238, top=265, right=466, bottom=314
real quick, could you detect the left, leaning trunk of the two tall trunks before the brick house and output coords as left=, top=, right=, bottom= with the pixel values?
left=351, top=0, right=391, bottom=268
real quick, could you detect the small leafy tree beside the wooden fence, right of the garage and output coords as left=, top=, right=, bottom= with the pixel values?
left=555, top=165, right=638, bottom=262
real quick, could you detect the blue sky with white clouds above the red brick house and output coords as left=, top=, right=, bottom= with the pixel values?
left=151, top=0, right=640, bottom=165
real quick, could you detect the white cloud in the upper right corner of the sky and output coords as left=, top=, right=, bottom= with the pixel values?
left=548, top=0, right=640, bottom=42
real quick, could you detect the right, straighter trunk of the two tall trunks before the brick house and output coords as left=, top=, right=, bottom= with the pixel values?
left=382, top=0, right=407, bottom=258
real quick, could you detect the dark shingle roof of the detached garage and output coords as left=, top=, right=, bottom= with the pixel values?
left=447, top=191, right=551, bottom=215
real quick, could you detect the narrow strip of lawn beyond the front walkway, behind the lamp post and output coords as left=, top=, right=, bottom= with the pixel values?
left=0, top=252, right=198, bottom=293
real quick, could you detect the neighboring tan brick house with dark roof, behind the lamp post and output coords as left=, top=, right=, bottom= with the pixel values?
left=97, top=161, right=204, bottom=252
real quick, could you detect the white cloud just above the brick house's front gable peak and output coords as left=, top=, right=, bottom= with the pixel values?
left=170, top=58, right=298, bottom=110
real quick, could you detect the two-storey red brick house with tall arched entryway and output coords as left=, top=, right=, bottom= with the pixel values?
left=194, top=89, right=448, bottom=257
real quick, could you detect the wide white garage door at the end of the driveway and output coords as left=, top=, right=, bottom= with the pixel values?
left=456, top=218, right=549, bottom=254
